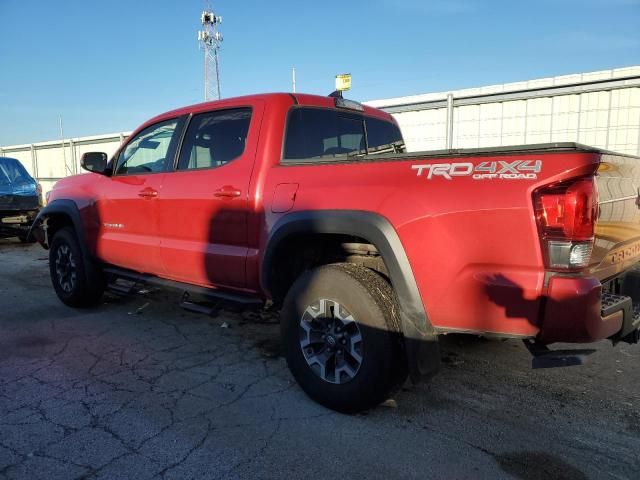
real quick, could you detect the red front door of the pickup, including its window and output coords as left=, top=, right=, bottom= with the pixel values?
left=97, top=119, right=182, bottom=274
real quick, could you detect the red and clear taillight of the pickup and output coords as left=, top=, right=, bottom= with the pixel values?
left=533, top=177, right=598, bottom=269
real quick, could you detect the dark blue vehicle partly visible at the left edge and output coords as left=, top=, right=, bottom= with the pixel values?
left=0, top=157, right=42, bottom=242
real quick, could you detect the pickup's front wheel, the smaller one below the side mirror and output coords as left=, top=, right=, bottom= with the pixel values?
left=49, top=227, right=105, bottom=308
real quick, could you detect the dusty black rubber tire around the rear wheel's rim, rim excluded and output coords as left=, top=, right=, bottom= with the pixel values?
left=281, top=263, right=408, bottom=413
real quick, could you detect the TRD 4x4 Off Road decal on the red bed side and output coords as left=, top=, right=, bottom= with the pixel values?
left=411, top=160, right=542, bottom=180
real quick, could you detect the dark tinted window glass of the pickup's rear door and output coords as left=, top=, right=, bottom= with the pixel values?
left=178, top=108, right=251, bottom=170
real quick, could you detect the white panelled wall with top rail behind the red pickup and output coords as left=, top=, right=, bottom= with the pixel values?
left=0, top=66, right=640, bottom=196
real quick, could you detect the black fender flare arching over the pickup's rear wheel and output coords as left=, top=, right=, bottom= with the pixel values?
left=260, top=210, right=440, bottom=381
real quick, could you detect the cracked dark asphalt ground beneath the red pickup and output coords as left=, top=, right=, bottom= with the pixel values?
left=0, top=240, right=640, bottom=480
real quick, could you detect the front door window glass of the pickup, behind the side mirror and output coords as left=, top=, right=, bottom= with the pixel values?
left=116, top=119, right=179, bottom=175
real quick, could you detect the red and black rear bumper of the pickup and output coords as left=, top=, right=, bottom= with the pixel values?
left=539, top=271, right=640, bottom=343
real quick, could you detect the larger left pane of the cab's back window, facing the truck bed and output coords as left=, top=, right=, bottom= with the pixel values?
left=284, top=108, right=366, bottom=161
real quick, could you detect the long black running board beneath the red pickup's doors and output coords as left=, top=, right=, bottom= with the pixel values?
left=104, top=267, right=264, bottom=307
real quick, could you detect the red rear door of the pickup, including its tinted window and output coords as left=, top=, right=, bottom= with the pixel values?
left=158, top=102, right=263, bottom=288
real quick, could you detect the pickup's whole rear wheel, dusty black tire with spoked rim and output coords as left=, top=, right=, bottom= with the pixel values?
left=281, top=263, right=407, bottom=413
